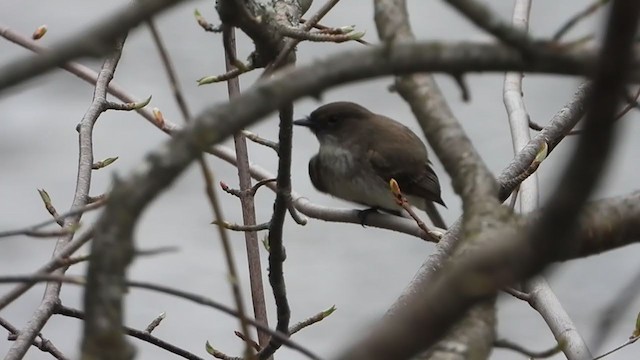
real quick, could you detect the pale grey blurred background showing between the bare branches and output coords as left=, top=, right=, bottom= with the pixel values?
left=0, top=0, right=640, bottom=359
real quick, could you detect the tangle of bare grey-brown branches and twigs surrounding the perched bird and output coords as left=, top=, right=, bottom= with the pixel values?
left=0, top=0, right=640, bottom=360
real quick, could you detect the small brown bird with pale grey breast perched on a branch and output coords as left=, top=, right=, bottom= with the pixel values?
left=293, top=102, right=446, bottom=228
